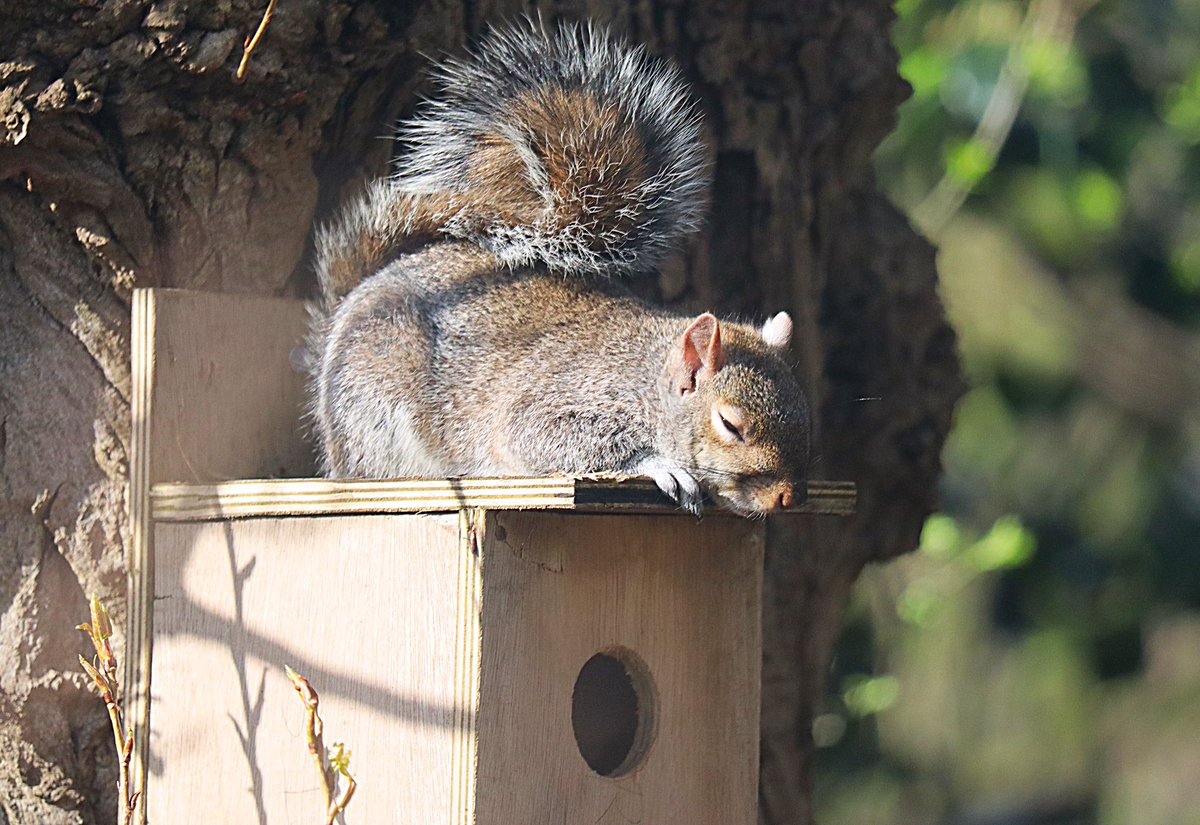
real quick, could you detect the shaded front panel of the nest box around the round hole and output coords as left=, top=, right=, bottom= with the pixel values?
left=475, top=512, right=764, bottom=825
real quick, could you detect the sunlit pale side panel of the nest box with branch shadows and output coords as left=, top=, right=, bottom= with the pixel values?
left=148, top=514, right=480, bottom=825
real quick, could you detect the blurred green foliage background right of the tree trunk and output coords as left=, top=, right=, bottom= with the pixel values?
left=812, top=0, right=1200, bottom=825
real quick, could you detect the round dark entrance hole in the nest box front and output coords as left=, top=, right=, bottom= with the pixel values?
left=571, top=648, right=655, bottom=777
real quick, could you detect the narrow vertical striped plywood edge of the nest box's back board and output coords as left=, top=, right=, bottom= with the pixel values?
left=125, top=289, right=155, bottom=825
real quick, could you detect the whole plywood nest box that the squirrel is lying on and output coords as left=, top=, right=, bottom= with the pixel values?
left=126, top=290, right=854, bottom=825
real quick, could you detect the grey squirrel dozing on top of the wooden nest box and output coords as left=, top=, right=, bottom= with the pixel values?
left=310, top=20, right=809, bottom=514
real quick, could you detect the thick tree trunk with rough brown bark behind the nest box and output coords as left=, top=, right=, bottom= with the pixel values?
left=0, top=0, right=960, bottom=824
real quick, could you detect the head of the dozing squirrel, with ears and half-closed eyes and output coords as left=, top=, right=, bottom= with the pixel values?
left=667, top=312, right=809, bottom=514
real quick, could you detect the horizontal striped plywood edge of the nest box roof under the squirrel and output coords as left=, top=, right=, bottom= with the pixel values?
left=151, top=477, right=857, bottom=522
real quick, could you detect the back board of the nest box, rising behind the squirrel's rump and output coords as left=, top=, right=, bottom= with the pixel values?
left=125, top=289, right=313, bottom=821
